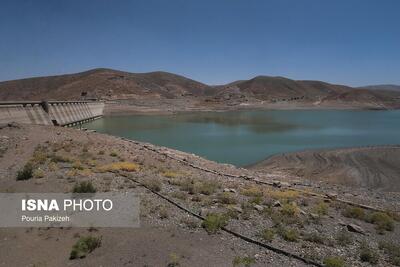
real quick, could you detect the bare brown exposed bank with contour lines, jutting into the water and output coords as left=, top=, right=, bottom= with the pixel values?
left=250, top=146, right=400, bottom=192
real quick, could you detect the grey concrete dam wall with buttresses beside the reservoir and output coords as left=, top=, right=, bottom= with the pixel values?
left=0, top=101, right=104, bottom=126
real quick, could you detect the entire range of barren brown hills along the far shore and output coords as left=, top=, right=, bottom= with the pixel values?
left=0, top=69, right=400, bottom=109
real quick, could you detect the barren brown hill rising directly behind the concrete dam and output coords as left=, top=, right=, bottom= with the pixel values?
left=0, top=69, right=208, bottom=100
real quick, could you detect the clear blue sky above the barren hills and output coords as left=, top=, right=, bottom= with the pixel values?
left=0, top=0, right=400, bottom=86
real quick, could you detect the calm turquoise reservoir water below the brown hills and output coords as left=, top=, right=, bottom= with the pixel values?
left=85, top=110, right=400, bottom=166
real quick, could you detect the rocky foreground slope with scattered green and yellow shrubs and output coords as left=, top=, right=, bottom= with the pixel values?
left=0, top=125, right=400, bottom=266
